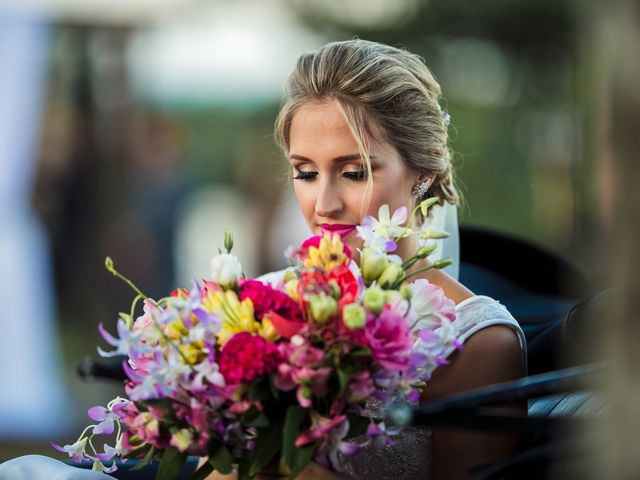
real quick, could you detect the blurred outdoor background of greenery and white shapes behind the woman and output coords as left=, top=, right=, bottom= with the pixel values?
left=0, top=0, right=632, bottom=466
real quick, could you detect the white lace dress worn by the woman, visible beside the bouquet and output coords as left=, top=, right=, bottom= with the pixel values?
left=339, top=295, right=527, bottom=480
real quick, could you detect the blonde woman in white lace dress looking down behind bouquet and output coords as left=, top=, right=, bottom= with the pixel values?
left=211, top=40, right=526, bottom=480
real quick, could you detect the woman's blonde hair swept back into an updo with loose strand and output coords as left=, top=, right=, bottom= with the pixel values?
left=275, top=40, right=459, bottom=218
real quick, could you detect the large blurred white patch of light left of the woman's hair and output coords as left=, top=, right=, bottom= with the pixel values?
left=128, top=0, right=322, bottom=106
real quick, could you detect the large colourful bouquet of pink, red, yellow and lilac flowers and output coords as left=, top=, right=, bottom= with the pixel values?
left=53, top=199, right=458, bottom=479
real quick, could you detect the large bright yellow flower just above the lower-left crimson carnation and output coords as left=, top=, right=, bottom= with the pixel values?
left=202, top=290, right=260, bottom=345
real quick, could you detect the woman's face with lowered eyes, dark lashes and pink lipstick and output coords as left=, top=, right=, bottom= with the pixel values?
left=289, top=101, right=420, bottom=256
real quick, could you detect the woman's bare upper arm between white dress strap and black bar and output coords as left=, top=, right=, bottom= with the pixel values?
left=423, top=325, right=525, bottom=400
